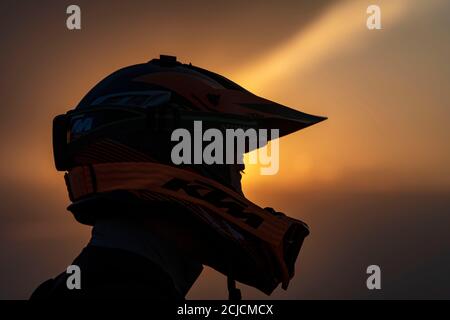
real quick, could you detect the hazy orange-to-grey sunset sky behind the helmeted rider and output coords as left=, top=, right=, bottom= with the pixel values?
left=0, top=0, right=450, bottom=299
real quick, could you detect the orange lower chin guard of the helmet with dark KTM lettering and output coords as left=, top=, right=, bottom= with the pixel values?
left=66, top=162, right=309, bottom=294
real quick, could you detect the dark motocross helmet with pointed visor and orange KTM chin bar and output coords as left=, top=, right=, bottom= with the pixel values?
left=53, top=55, right=326, bottom=294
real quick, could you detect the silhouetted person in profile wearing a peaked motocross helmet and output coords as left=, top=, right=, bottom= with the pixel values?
left=31, top=56, right=324, bottom=300
